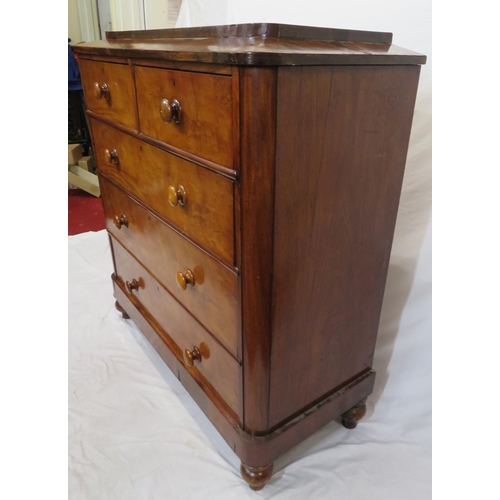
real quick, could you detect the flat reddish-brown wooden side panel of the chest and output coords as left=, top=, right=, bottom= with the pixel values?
left=269, top=66, right=420, bottom=428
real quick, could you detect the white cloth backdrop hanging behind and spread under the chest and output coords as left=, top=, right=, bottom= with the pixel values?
left=69, top=0, right=432, bottom=500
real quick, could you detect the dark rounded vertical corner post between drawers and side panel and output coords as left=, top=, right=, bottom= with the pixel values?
left=240, top=68, right=276, bottom=434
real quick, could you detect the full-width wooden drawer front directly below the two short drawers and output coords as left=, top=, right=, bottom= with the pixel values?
left=92, top=120, right=234, bottom=264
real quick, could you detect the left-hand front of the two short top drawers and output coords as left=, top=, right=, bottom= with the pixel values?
left=80, top=59, right=137, bottom=130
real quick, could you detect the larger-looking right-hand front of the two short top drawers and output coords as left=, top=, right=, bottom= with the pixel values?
left=135, top=66, right=233, bottom=168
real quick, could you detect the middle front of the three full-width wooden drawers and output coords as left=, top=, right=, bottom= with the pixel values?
left=100, top=176, right=239, bottom=356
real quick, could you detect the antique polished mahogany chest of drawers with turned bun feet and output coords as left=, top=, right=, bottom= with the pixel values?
left=75, top=24, right=425, bottom=489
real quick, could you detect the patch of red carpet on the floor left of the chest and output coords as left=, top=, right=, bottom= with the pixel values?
left=68, top=189, right=106, bottom=236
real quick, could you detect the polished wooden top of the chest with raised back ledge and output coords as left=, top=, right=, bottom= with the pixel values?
left=75, top=24, right=426, bottom=66
